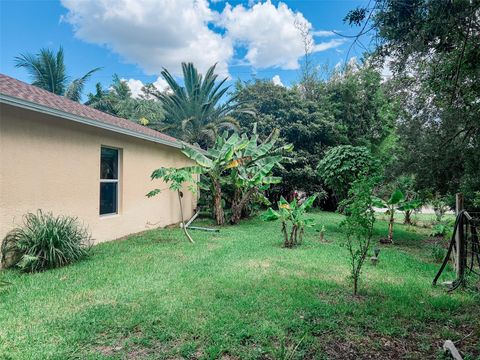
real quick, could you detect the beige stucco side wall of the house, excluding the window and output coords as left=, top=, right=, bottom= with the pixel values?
left=0, top=104, right=196, bottom=243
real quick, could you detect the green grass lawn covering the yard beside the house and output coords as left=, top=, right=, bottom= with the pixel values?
left=0, top=213, right=480, bottom=359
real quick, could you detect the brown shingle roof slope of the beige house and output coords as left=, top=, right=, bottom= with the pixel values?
left=0, top=74, right=182, bottom=147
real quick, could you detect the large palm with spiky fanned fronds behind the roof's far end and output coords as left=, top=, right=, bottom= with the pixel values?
left=153, top=63, right=251, bottom=147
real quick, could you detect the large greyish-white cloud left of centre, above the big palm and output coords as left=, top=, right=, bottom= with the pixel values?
left=62, top=0, right=233, bottom=74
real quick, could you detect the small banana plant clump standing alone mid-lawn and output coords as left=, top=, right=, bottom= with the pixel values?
left=263, top=195, right=316, bottom=248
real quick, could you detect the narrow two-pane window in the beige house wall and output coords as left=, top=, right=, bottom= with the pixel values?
left=100, top=147, right=118, bottom=215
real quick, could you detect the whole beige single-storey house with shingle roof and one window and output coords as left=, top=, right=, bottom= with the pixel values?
left=0, top=74, right=196, bottom=243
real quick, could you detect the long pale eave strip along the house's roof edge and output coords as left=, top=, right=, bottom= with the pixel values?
left=0, top=93, right=184, bottom=149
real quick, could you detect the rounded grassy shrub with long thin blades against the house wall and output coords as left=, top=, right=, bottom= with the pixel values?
left=2, top=210, right=91, bottom=272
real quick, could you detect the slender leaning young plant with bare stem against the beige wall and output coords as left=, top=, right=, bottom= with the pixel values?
left=147, top=166, right=203, bottom=243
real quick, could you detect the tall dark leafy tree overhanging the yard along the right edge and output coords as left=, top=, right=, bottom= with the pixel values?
left=346, top=0, right=480, bottom=207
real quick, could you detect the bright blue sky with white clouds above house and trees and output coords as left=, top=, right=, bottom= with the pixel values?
left=0, top=0, right=365, bottom=97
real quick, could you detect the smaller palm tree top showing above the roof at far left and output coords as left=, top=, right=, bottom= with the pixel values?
left=15, top=47, right=100, bottom=102
